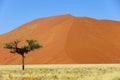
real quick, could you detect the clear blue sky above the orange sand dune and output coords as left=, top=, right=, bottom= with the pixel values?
left=0, top=0, right=120, bottom=34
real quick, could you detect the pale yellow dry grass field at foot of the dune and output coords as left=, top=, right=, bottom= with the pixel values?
left=0, top=64, right=120, bottom=80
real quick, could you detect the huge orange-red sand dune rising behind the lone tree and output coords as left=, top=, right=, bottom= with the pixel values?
left=0, top=14, right=120, bottom=64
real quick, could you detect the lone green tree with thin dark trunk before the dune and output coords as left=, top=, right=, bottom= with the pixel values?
left=4, top=40, right=42, bottom=70
